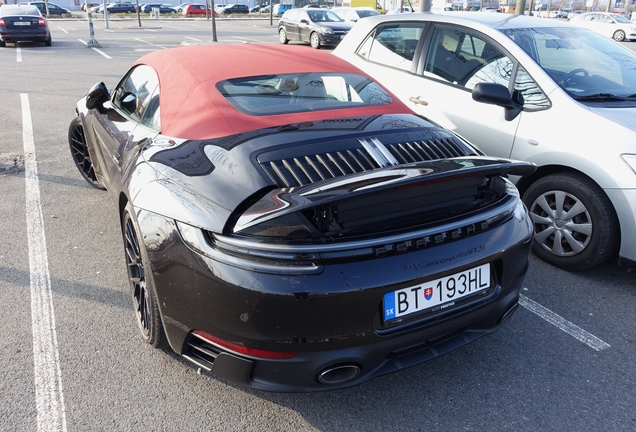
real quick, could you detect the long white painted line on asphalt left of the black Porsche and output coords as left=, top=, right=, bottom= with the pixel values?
left=20, top=93, right=66, bottom=431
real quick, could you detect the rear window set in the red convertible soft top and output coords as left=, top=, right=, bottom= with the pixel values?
left=216, top=72, right=393, bottom=116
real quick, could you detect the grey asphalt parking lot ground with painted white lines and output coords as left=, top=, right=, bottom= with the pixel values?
left=0, top=19, right=636, bottom=431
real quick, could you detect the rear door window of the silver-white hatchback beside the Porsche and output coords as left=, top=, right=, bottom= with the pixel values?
left=358, top=23, right=424, bottom=71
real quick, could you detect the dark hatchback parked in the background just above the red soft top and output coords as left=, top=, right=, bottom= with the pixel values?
left=278, top=8, right=352, bottom=49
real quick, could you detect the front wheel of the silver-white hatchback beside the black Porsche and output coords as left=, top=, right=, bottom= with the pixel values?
left=523, top=173, right=620, bottom=270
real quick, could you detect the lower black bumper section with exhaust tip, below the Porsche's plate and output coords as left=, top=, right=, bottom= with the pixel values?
left=183, top=286, right=521, bottom=393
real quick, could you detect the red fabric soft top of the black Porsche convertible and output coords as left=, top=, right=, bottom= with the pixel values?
left=135, top=44, right=412, bottom=139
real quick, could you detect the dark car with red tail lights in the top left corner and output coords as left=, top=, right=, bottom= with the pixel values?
left=0, top=5, right=51, bottom=47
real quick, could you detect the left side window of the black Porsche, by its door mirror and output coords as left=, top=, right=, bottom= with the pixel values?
left=113, top=65, right=159, bottom=121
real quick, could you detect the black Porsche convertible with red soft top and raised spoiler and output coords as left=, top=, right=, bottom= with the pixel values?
left=69, top=44, right=535, bottom=392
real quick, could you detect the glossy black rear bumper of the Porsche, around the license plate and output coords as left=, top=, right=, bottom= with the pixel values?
left=138, top=193, right=532, bottom=392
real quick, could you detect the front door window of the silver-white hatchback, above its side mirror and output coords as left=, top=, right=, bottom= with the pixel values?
left=424, top=26, right=514, bottom=90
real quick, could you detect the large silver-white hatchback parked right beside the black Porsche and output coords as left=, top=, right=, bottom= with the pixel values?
left=334, top=12, right=636, bottom=270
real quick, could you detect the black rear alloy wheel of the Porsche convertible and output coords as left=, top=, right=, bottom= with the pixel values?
left=122, top=203, right=166, bottom=348
